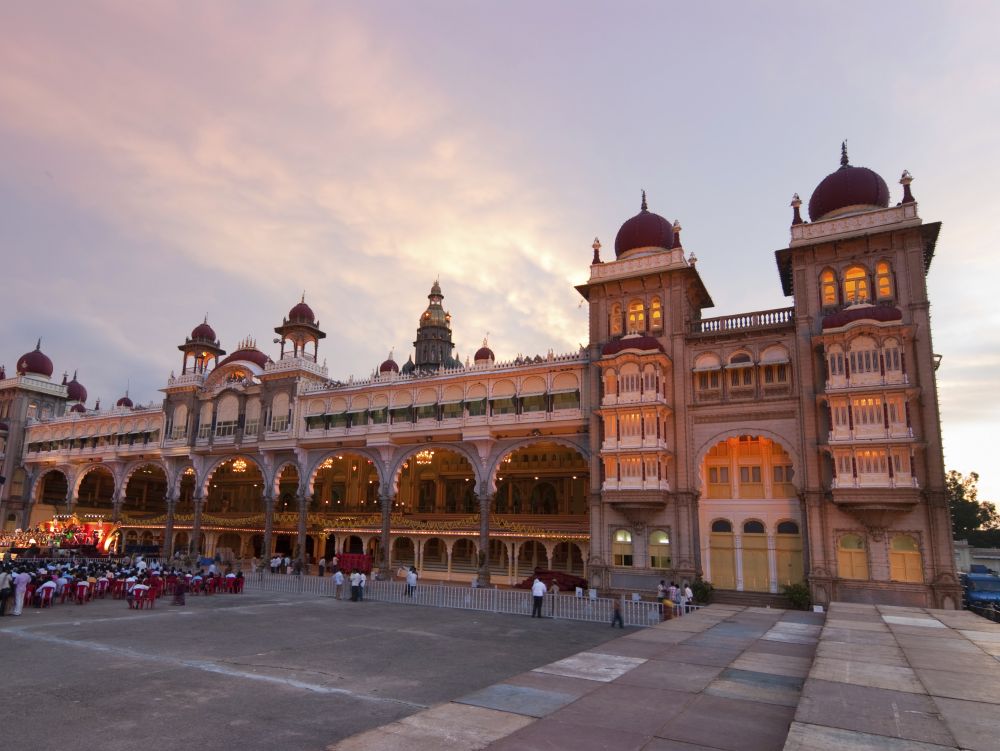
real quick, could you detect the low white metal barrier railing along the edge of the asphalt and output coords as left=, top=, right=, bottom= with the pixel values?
left=246, top=571, right=700, bottom=626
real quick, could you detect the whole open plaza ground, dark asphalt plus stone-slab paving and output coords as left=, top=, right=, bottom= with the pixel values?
left=0, top=593, right=1000, bottom=751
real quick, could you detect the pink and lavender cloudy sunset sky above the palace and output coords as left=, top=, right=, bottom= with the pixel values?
left=0, top=0, right=1000, bottom=499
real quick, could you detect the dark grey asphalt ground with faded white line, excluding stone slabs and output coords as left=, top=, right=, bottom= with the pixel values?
left=0, top=592, right=627, bottom=751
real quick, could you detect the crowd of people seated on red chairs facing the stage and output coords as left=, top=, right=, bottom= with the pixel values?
left=0, top=557, right=243, bottom=615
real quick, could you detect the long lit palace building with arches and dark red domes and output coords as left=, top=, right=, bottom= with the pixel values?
left=0, top=149, right=960, bottom=608
